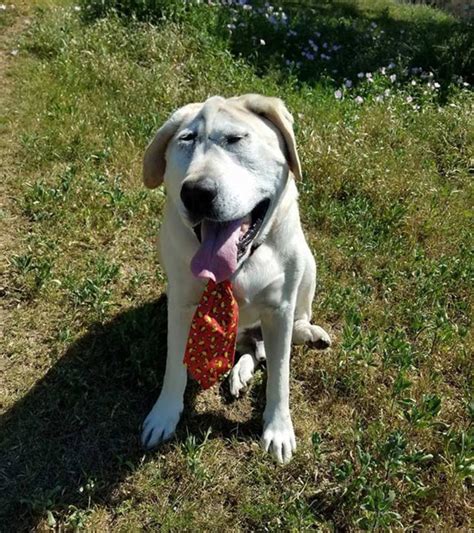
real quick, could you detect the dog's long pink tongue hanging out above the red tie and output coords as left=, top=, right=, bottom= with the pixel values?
left=191, top=219, right=243, bottom=283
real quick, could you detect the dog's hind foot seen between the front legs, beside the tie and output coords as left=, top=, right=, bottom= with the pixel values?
left=229, top=328, right=266, bottom=398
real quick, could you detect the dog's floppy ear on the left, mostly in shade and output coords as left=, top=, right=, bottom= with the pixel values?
left=143, top=104, right=202, bottom=189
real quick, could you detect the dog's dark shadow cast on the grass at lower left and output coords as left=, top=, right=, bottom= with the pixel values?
left=0, top=296, right=259, bottom=531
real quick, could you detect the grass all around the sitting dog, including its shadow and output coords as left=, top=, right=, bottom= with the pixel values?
left=0, top=0, right=474, bottom=531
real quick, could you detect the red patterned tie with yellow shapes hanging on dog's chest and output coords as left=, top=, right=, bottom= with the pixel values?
left=183, top=280, right=239, bottom=389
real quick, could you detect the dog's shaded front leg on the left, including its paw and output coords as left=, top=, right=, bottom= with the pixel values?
left=141, top=289, right=195, bottom=448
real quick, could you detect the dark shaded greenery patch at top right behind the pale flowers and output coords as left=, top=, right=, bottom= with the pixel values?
left=219, top=0, right=474, bottom=84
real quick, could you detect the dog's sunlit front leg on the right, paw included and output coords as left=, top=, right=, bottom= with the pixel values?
left=261, top=303, right=296, bottom=463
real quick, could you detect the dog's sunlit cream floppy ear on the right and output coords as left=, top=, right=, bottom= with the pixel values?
left=231, top=94, right=301, bottom=179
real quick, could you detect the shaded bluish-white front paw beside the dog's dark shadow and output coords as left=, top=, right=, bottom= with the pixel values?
left=141, top=398, right=183, bottom=450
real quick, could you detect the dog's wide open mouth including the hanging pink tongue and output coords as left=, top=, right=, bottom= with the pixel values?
left=191, top=199, right=270, bottom=283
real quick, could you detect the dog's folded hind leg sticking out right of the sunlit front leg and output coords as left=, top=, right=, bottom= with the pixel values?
left=292, top=248, right=331, bottom=350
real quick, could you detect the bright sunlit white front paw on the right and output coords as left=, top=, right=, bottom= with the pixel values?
left=262, top=414, right=296, bottom=463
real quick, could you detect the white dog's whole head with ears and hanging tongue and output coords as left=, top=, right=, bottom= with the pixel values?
left=143, top=94, right=301, bottom=281
